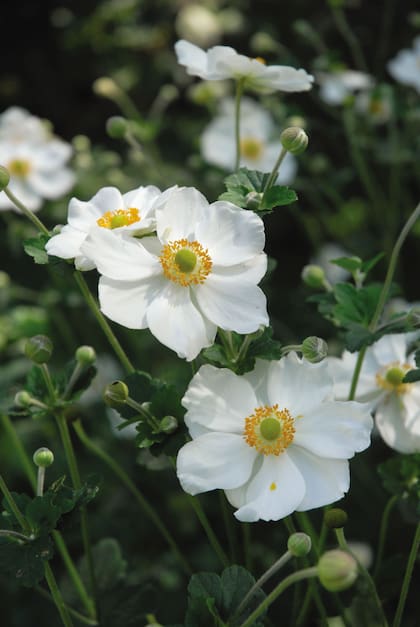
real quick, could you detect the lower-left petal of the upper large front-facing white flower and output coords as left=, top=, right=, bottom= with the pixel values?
left=98, top=277, right=164, bottom=329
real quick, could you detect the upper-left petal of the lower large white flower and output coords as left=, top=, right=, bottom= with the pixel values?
left=182, top=365, right=257, bottom=435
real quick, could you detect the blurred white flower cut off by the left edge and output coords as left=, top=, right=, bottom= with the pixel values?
left=0, top=107, right=75, bottom=211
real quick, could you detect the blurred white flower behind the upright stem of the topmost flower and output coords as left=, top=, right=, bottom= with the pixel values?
left=201, top=98, right=297, bottom=184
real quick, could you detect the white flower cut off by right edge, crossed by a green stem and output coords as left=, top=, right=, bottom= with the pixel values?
left=328, top=334, right=420, bottom=453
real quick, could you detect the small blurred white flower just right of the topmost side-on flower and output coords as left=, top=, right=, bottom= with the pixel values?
left=316, top=70, right=374, bottom=106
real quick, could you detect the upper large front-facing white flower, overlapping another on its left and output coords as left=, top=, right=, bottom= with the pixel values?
left=81, top=188, right=268, bottom=360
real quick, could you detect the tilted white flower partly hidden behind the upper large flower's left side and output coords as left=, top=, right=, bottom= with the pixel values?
left=45, top=185, right=162, bottom=270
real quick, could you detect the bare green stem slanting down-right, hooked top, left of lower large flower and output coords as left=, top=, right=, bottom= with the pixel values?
left=73, top=420, right=192, bottom=575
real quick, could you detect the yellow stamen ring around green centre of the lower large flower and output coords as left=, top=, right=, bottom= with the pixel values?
left=243, top=405, right=295, bottom=456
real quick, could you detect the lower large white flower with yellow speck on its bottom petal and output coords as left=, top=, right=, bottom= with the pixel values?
left=177, top=353, right=372, bottom=522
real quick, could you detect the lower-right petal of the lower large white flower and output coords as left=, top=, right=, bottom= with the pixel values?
left=287, top=445, right=350, bottom=511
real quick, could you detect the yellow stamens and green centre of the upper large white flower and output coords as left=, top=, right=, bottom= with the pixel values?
left=159, top=239, right=213, bottom=287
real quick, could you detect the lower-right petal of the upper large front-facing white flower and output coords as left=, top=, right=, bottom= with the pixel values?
left=194, top=273, right=269, bottom=333
